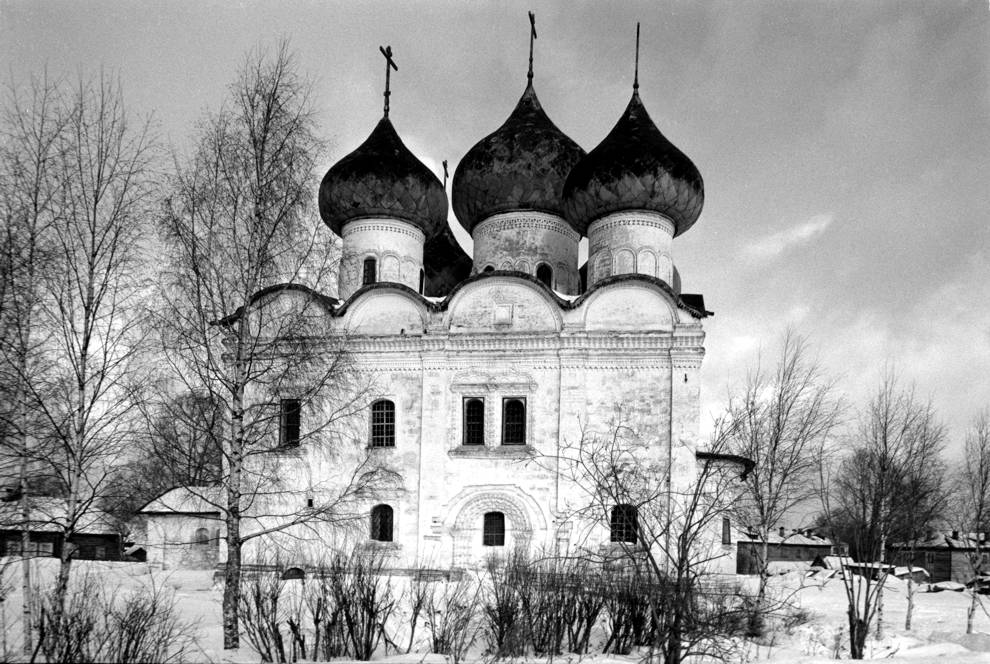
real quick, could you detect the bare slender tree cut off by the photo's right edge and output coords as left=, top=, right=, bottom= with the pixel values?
left=956, top=409, right=990, bottom=634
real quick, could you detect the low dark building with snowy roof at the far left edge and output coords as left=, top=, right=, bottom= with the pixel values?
left=0, top=496, right=121, bottom=560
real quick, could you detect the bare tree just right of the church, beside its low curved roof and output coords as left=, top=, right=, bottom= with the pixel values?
left=728, top=330, right=842, bottom=633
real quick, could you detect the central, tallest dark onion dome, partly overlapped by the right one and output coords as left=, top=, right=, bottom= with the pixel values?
left=453, top=83, right=584, bottom=233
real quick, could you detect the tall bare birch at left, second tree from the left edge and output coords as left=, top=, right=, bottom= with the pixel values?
left=26, top=75, right=155, bottom=601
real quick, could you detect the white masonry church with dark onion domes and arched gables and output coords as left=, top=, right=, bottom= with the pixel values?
left=143, top=26, right=748, bottom=569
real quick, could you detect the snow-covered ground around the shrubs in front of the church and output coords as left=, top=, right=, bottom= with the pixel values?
left=0, top=559, right=990, bottom=664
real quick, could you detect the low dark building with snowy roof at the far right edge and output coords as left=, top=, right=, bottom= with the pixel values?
left=887, top=530, right=990, bottom=583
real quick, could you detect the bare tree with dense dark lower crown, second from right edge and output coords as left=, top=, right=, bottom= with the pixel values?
left=822, top=369, right=945, bottom=659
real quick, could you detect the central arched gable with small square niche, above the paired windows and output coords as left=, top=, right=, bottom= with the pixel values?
left=444, top=276, right=563, bottom=333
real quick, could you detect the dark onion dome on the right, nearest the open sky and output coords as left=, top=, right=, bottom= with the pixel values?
left=564, top=92, right=705, bottom=236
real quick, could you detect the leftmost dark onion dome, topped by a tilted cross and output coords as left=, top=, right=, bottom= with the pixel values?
left=320, top=117, right=447, bottom=238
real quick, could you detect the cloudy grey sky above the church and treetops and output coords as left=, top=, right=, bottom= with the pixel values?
left=0, top=0, right=990, bottom=451
